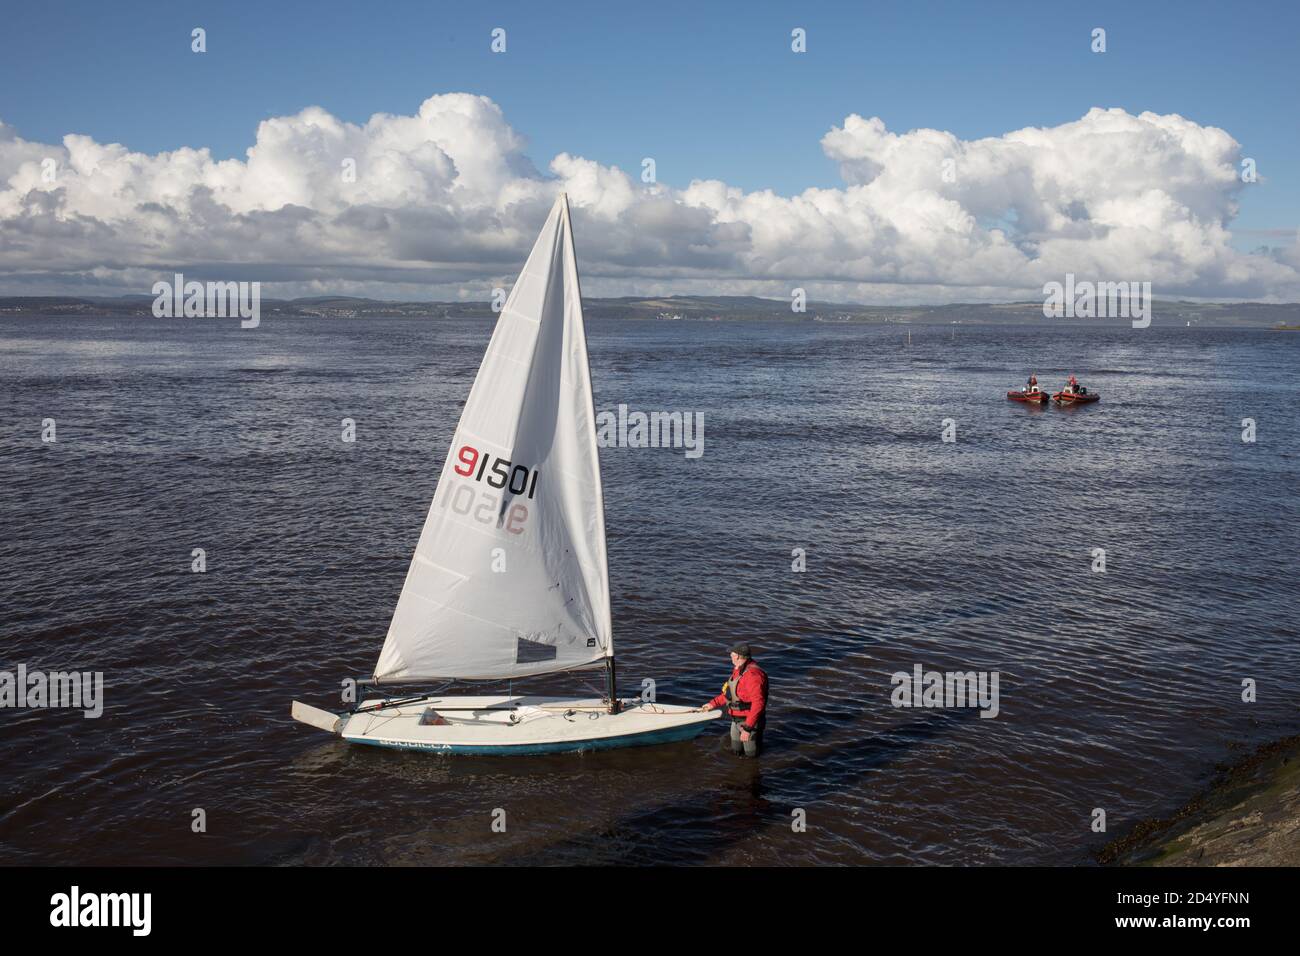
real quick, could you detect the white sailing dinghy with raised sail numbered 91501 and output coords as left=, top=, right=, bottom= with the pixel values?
left=291, top=194, right=719, bottom=754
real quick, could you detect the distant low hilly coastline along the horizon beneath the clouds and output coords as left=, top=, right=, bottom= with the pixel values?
left=0, top=295, right=1300, bottom=330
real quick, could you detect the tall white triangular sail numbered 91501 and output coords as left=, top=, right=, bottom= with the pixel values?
left=374, top=195, right=614, bottom=682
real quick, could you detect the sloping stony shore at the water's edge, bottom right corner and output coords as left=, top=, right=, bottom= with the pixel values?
left=1096, top=734, right=1300, bottom=866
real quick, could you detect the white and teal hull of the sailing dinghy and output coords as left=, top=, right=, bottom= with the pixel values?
left=327, top=696, right=720, bottom=756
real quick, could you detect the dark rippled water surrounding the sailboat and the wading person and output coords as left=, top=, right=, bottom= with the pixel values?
left=0, top=319, right=1300, bottom=864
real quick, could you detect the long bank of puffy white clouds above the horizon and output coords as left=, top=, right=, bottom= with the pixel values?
left=0, top=94, right=1300, bottom=302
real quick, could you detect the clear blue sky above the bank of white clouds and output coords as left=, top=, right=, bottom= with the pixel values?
left=0, top=0, right=1300, bottom=299
